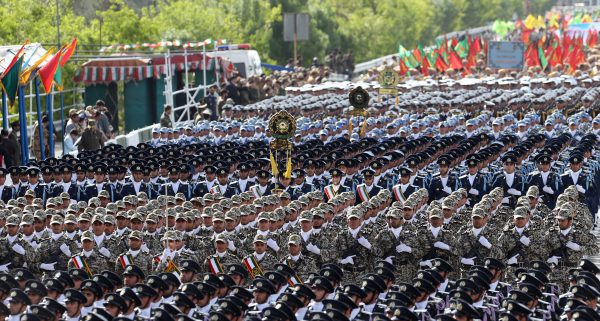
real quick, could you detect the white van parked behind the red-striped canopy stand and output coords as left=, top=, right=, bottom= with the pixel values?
left=208, top=44, right=263, bottom=78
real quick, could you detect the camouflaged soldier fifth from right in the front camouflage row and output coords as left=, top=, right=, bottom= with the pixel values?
left=373, top=208, right=430, bottom=282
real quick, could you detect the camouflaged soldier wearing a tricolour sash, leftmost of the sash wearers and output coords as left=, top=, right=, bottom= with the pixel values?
left=68, top=231, right=112, bottom=277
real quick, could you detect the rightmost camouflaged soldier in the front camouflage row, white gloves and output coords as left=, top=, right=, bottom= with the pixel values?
left=544, top=207, right=598, bottom=289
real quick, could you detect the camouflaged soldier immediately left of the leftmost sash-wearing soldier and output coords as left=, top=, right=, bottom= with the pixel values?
left=35, top=215, right=77, bottom=273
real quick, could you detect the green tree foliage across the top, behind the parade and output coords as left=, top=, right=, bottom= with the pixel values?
left=0, top=0, right=552, bottom=67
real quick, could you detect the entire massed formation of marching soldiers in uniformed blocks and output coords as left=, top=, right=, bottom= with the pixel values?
left=0, top=72, right=600, bottom=321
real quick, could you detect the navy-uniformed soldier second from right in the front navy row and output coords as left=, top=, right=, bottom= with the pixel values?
left=527, top=154, right=562, bottom=209
